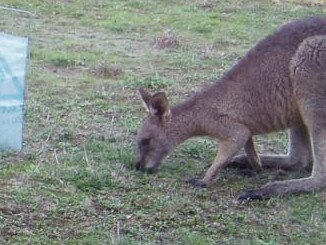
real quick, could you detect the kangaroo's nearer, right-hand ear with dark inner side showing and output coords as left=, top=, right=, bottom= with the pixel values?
left=149, top=92, right=171, bottom=122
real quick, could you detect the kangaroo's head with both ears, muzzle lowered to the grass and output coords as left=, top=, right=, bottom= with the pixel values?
left=136, top=88, right=173, bottom=173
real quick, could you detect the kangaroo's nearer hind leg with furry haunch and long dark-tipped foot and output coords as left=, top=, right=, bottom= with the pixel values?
left=237, top=36, right=326, bottom=200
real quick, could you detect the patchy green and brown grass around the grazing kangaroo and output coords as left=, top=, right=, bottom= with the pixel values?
left=0, top=0, right=326, bottom=245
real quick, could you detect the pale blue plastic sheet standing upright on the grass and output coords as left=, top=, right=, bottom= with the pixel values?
left=0, top=33, right=28, bottom=150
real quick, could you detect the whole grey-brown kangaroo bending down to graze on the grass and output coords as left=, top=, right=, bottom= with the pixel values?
left=136, top=17, right=326, bottom=200
